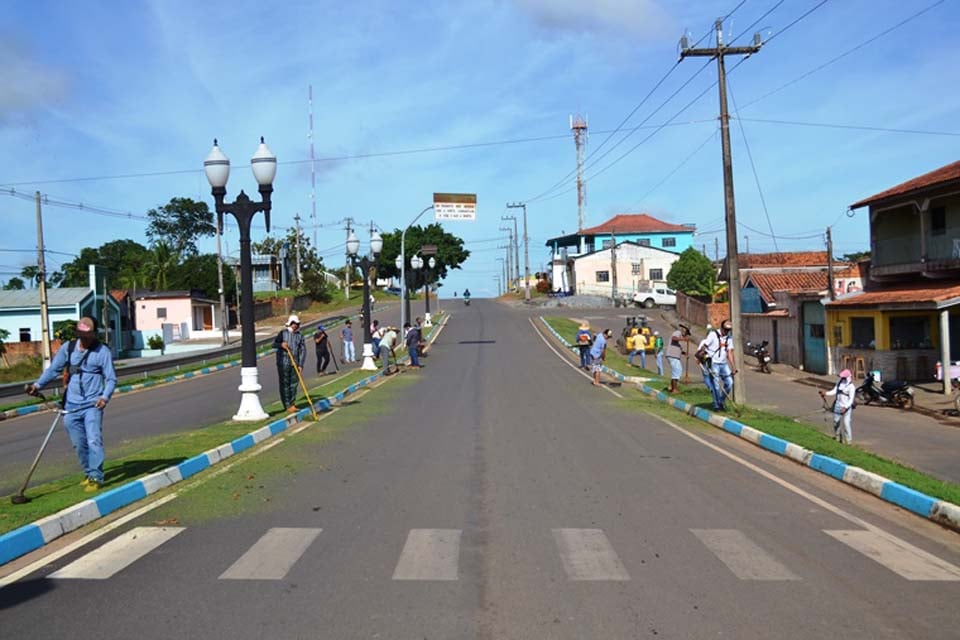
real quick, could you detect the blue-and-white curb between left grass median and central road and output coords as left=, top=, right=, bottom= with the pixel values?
left=0, top=314, right=449, bottom=565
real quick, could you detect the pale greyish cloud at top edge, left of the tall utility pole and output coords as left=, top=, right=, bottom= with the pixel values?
left=515, top=0, right=676, bottom=38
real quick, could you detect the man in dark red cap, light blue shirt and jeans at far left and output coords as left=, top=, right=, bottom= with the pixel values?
left=25, top=318, right=117, bottom=492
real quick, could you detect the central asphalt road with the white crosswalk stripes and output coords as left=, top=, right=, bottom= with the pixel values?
left=0, top=300, right=960, bottom=640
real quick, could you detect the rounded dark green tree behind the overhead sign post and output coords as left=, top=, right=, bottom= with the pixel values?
left=377, top=223, right=470, bottom=290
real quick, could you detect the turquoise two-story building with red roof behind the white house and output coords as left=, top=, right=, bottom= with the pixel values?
left=546, top=213, right=696, bottom=292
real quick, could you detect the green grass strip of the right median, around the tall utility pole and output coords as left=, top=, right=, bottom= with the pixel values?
left=544, top=317, right=960, bottom=504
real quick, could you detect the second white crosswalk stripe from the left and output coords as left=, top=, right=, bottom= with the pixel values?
left=220, top=527, right=323, bottom=580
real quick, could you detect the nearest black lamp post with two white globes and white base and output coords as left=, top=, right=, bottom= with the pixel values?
left=203, top=137, right=277, bottom=422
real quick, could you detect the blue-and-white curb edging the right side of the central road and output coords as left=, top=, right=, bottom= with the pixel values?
left=540, top=316, right=960, bottom=531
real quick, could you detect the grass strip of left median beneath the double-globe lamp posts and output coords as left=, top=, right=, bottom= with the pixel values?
left=0, top=370, right=390, bottom=533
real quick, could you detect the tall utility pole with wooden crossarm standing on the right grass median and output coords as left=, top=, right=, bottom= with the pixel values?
left=680, top=20, right=763, bottom=403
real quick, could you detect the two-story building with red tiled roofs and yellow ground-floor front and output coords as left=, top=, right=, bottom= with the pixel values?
left=826, top=161, right=960, bottom=393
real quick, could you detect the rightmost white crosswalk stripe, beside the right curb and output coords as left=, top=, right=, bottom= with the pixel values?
left=824, top=530, right=960, bottom=581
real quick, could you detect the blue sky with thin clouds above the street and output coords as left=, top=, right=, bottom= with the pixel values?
left=0, top=0, right=960, bottom=295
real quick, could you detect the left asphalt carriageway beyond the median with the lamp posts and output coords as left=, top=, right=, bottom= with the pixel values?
left=0, top=306, right=404, bottom=495
